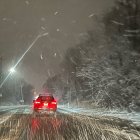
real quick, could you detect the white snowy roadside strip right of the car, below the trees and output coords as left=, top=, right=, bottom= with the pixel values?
left=58, top=105, right=140, bottom=126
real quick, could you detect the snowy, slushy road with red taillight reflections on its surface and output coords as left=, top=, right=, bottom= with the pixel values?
left=0, top=105, right=140, bottom=140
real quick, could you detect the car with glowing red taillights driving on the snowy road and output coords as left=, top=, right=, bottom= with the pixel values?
left=33, top=94, right=57, bottom=113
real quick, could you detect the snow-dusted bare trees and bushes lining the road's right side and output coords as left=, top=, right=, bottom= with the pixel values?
left=43, top=0, right=140, bottom=110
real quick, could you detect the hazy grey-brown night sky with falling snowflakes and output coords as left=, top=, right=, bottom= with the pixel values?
left=0, top=0, right=114, bottom=89
